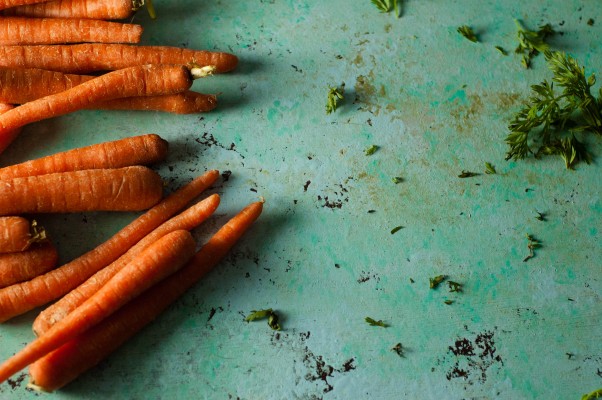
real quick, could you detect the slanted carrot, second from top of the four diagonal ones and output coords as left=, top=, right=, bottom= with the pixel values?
left=33, top=194, right=219, bottom=336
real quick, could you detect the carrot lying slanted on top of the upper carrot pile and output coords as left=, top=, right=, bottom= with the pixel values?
left=0, top=64, right=192, bottom=152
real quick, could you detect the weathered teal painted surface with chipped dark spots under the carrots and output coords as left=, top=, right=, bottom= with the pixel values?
left=0, top=0, right=602, bottom=399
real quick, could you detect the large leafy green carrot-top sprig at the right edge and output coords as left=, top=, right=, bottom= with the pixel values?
left=505, top=51, right=602, bottom=169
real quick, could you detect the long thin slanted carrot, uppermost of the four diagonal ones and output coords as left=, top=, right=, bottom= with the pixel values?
left=0, top=170, right=219, bottom=322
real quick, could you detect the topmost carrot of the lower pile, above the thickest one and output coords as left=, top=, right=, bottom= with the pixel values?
left=0, top=134, right=168, bottom=181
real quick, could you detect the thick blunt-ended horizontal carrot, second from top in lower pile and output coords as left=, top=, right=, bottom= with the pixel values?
left=0, top=166, right=163, bottom=215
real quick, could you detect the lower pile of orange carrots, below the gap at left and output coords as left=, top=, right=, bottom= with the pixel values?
left=0, top=134, right=263, bottom=391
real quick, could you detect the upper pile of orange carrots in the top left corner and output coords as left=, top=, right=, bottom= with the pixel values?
left=0, top=0, right=238, bottom=152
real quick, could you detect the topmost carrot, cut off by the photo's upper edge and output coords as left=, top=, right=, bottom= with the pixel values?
left=4, top=0, right=136, bottom=20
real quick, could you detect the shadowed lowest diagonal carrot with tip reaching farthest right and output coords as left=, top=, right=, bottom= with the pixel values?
left=28, top=202, right=263, bottom=391
